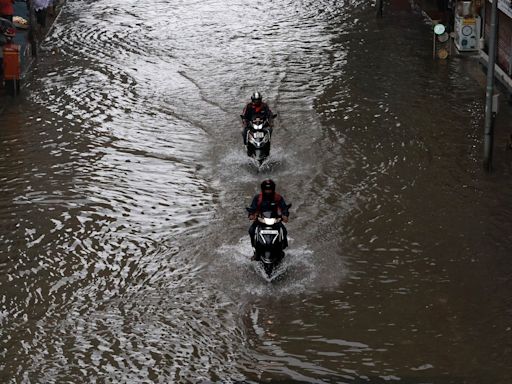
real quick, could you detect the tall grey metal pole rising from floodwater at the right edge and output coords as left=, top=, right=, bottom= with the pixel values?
left=484, top=0, right=498, bottom=172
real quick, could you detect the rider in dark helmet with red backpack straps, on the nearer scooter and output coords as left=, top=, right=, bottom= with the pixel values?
left=248, top=179, right=290, bottom=260
